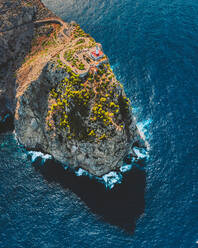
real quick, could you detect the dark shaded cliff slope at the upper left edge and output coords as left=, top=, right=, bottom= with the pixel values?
left=0, top=0, right=54, bottom=132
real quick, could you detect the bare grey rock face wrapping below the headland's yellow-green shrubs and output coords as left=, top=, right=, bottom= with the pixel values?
left=15, top=61, right=143, bottom=176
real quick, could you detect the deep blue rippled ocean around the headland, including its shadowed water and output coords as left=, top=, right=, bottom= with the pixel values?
left=0, top=0, right=198, bottom=248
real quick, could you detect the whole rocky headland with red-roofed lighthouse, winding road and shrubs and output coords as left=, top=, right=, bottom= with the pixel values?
left=0, top=0, right=145, bottom=176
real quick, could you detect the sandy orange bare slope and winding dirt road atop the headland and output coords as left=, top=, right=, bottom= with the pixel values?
left=16, top=17, right=97, bottom=102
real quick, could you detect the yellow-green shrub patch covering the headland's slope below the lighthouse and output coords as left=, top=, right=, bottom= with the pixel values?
left=48, top=60, right=129, bottom=142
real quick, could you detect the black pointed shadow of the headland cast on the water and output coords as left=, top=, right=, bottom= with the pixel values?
left=35, top=161, right=146, bottom=234
